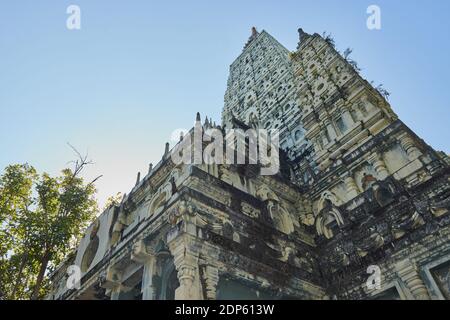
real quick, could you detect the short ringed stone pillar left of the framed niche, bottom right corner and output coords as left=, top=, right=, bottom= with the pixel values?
left=395, top=259, right=430, bottom=300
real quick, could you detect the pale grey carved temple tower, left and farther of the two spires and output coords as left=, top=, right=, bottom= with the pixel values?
left=222, top=28, right=309, bottom=166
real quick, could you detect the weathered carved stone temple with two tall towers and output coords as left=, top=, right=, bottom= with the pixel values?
left=49, top=29, right=450, bottom=300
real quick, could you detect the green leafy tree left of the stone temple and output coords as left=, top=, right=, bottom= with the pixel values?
left=0, top=152, right=98, bottom=299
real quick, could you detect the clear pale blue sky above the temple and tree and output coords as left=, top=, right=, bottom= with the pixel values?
left=0, top=0, right=450, bottom=209
